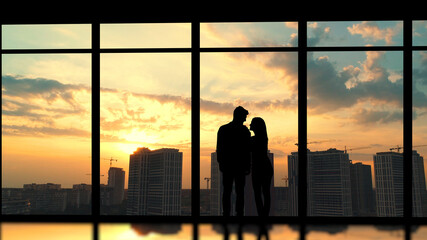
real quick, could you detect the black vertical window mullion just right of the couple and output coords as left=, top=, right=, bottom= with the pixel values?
left=297, top=19, right=307, bottom=240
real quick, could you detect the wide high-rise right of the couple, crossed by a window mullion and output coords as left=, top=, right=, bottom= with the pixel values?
left=288, top=148, right=353, bottom=216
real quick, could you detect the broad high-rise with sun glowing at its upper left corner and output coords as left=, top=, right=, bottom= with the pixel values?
left=127, top=148, right=182, bottom=216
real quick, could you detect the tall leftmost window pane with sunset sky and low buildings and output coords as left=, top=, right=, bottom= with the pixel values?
left=2, top=54, right=92, bottom=215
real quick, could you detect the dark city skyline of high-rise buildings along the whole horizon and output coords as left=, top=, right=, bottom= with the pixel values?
left=2, top=148, right=427, bottom=217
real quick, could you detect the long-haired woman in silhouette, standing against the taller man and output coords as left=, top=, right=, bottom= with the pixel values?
left=250, top=117, right=273, bottom=216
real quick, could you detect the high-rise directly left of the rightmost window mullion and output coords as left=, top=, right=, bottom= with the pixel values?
left=374, top=152, right=403, bottom=217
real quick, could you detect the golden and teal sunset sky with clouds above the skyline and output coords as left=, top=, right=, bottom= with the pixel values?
left=2, top=22, right=427, bottom=188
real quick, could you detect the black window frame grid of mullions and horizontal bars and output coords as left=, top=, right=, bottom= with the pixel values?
left=0, top=16, right=427, bottom=240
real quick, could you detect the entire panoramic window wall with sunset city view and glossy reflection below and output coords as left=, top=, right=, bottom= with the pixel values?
left=1, top=19, right=427, bottom=240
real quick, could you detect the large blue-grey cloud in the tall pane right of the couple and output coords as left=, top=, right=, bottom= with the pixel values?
left=307, top=52, right=403, bottom=114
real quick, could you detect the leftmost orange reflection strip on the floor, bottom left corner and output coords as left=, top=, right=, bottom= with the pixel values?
left=0, top=223, right=93, bottom=240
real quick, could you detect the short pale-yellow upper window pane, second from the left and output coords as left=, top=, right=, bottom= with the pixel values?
left=101, top=23, right=191, bottom=48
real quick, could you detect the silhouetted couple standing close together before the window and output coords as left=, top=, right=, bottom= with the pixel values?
left=216, top=106, right=273, bottom=216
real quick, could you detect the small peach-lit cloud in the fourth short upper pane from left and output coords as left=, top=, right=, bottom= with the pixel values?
left=347, top=21, right=402, bottom=45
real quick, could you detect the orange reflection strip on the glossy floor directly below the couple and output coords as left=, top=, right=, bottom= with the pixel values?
left=199, top=224, right=300, bottom=240
